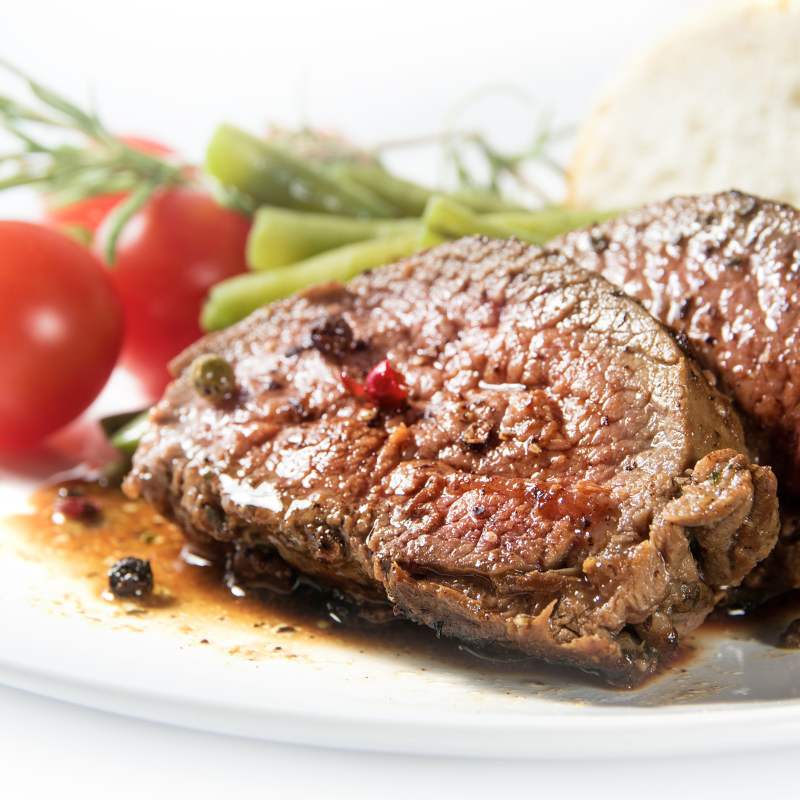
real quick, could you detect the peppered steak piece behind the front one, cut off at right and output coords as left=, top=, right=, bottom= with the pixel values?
left=548, top=192, right=800, bottom=592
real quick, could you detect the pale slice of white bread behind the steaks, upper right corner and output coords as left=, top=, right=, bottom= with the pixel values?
left=570, top=0, right=800, bottom=208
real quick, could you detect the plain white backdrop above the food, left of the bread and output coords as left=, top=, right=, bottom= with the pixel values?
left=0, top=0, right=709, bottom=209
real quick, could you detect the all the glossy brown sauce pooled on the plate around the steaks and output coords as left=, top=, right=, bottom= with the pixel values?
left=10, top=483, right=800, bottom=690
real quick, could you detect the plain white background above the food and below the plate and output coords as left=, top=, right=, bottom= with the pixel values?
left=0, top=0, right=800, bottom=800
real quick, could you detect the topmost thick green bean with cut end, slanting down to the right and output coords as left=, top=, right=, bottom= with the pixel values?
left=206, top=125, right=397, bottom=218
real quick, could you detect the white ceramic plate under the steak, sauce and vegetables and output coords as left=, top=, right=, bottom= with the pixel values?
left=0, top=372, right=800, bottom=758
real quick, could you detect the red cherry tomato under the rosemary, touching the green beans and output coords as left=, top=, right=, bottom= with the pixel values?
left=99, top=188, right=250, bottom=398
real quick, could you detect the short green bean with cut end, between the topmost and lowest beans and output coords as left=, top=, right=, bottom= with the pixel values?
left=247, top=206, right=419, bottom=270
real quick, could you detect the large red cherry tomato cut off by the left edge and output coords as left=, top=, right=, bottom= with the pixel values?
left=0, top=221, right=122, bottom=450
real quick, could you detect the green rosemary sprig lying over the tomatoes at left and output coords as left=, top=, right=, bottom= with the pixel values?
left=0, top=59, right=194, bottom=265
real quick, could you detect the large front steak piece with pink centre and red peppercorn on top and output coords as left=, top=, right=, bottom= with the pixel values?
left=126, top=239, right=778, bottom=684
